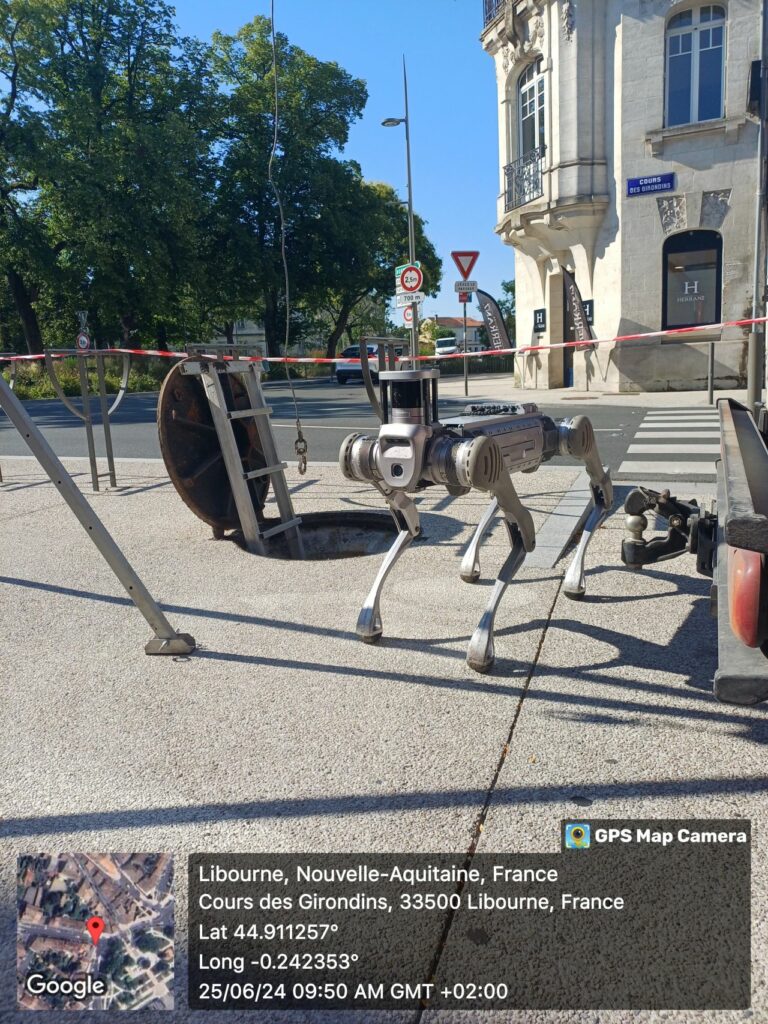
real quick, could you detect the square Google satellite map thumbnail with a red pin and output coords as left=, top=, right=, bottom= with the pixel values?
left=16, top=853, right=173, bottom=1010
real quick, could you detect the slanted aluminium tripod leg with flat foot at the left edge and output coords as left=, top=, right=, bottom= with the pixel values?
left=0, top=374, right=196, bottom=654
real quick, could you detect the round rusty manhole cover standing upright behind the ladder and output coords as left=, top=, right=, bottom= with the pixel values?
left=158, top=359, right=269, bottom=531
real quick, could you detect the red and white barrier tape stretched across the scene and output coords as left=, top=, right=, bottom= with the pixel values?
left=0, top=316, right=768, bottom=366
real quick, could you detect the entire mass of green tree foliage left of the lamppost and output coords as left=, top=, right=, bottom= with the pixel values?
left=0, top=0, right=440, bottom=353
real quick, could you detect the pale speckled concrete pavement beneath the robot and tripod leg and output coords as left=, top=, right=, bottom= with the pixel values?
left=0, top=460, right=768, bottom=1024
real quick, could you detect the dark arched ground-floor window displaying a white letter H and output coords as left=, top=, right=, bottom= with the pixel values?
left=662, top=231, right=723, bottom=331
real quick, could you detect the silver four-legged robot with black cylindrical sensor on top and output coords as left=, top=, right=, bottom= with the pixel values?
left=339, top=364, right=613, bottom=673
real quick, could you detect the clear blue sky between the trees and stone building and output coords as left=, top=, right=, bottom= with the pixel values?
left=171, top=0, right=514, bottom=316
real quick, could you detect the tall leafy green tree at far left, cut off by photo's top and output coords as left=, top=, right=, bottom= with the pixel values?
left=0, top=0, right=217, bottom=350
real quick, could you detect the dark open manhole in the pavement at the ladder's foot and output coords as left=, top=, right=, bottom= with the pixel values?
left=230, top=511, right=397, bottom=561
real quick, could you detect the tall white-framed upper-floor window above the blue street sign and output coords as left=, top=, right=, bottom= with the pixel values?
left=667, top=3, right=725, bottom=127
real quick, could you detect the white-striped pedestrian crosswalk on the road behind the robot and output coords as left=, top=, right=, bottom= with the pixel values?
left=616, top=408, right=720, bottom=479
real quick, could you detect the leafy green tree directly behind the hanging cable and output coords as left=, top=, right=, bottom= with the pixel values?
left=211, top=17, right=367, bottom=354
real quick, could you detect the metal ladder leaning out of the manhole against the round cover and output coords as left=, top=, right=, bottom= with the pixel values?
left=180, top=352, right=304, bottom=558
